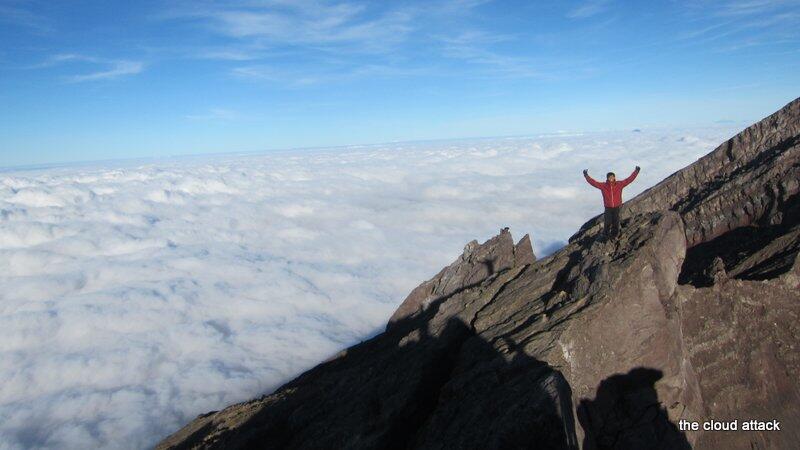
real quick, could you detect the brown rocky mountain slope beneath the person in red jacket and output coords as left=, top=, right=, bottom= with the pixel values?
left=158, top=99, right=800, bottom=449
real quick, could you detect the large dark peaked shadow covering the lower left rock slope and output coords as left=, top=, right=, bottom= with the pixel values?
left=158, top=292, right=578, bottom=450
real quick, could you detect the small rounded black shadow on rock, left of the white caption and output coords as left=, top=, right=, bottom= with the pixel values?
left=577, top=367, right=691, bottom=450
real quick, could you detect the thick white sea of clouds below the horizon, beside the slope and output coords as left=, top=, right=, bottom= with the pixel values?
left=0, top=128, right=736, bottom=450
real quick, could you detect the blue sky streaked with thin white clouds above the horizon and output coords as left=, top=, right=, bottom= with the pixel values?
left=0, top=0, right=800, bottom=167
